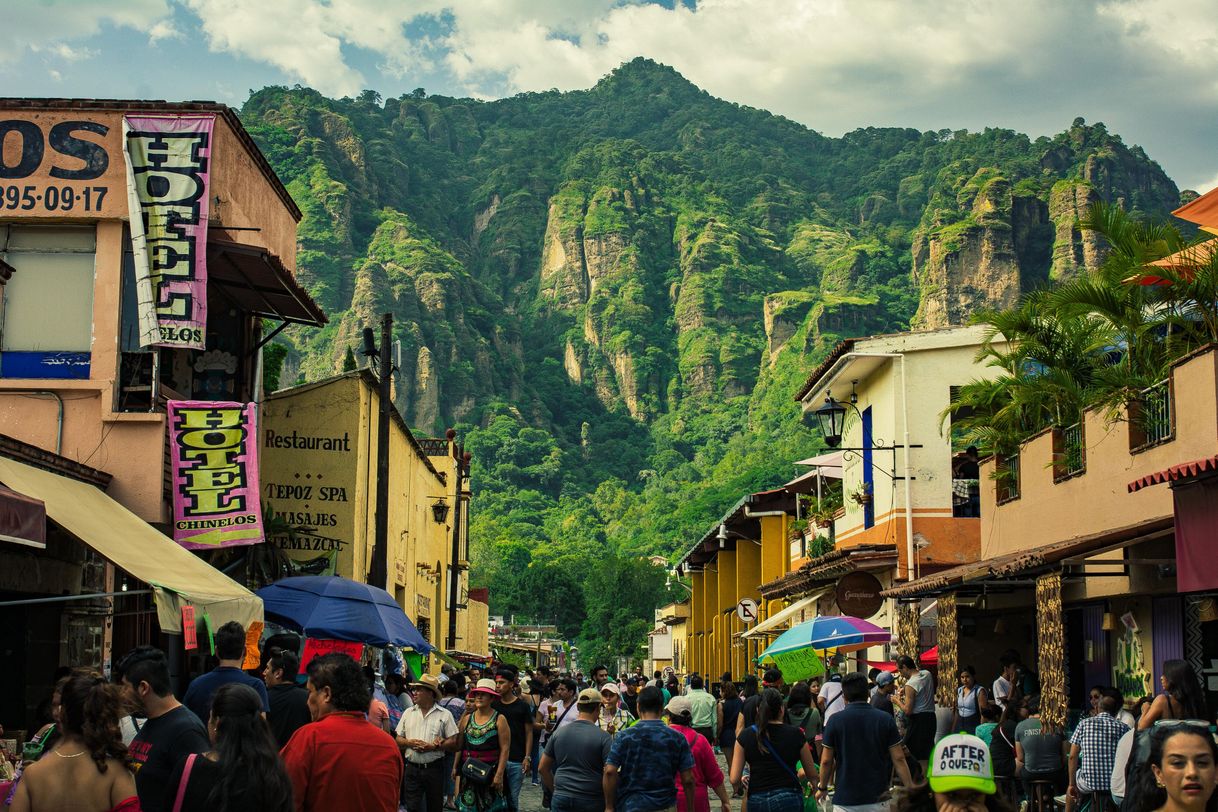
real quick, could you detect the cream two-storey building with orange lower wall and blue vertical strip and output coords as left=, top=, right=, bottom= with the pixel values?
left=745, top=326, right=1003, bottom=667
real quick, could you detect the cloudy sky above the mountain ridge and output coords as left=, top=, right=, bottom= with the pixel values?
left=0, top=0, right=1218, bottom=191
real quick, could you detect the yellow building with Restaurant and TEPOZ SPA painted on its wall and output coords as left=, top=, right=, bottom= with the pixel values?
left=259, top=370, right=485, bottom=670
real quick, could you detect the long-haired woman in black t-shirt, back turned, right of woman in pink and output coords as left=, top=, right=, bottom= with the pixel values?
left=731, top=688, right=817, bottom=812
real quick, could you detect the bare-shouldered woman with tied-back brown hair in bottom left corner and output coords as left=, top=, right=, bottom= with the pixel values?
left=10, top=674, right=140, bottom=812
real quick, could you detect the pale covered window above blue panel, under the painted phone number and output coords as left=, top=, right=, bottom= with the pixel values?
left=0, top=225, right=97, bottom=379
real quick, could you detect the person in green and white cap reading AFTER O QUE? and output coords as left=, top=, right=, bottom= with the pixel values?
left=896, top=733, right=1013, bottom=812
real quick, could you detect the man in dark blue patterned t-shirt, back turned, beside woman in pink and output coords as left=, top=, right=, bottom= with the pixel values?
left=603, top=685, right=694, bottom=812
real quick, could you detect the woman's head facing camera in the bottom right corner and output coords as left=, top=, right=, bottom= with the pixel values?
left=1122, top=719, right=1218, bottom=812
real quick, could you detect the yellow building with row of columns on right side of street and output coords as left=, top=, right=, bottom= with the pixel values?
left=677, top=488, right=795, bottom=678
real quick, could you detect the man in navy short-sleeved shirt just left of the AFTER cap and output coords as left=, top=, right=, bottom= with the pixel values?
left=816, top=672, right=914, bottom=812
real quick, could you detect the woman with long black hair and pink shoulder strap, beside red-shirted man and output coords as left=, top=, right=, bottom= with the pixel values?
left=164, top=683, right=295, bottom=812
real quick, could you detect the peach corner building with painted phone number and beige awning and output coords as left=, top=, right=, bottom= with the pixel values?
left=0, top=99, right=325, bottom=729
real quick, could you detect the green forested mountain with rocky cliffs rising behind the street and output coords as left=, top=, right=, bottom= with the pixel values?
left=241, top=60, right=1180, bottom=667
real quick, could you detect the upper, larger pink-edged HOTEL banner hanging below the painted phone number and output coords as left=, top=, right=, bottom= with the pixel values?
left=123, top=116, right=216, bottom=349
